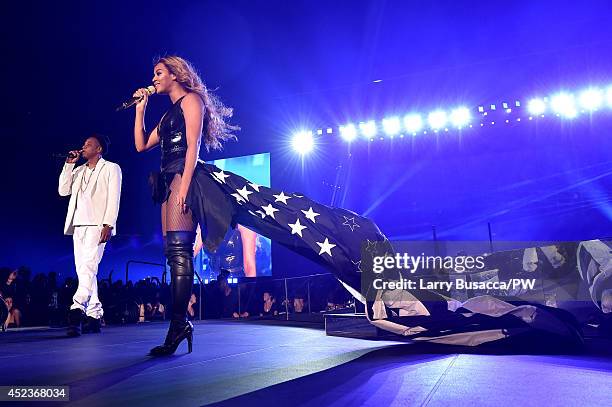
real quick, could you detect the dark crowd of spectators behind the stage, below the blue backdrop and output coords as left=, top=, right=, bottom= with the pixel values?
left=0, top=267, right=354, bottom=330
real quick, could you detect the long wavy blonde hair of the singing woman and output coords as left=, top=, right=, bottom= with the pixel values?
left=153, top=55, right=240, bottom=150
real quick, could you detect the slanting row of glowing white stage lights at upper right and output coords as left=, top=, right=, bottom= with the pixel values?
left=291, top=86, right=612, bottom=154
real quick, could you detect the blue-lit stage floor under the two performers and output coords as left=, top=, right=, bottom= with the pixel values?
left=0, top=321, right=612, bottom=407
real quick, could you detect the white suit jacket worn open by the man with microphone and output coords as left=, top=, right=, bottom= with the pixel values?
left=58, top=158, right=121, bottom=236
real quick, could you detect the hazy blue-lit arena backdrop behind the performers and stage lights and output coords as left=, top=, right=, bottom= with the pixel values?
left=0, top=0, right=612, bottom=277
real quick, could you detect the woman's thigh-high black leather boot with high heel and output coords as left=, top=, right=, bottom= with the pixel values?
left=150, top=232, right=195, bottom=356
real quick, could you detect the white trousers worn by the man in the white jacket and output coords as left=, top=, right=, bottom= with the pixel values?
left=70, top=226, right=106, bottom=319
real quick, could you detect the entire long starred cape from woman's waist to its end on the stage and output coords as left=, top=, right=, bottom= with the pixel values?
left=178, top=161, right=580, bottom=346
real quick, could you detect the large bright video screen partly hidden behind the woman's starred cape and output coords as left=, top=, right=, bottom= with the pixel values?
left=195, top=153, right=272, bottom=281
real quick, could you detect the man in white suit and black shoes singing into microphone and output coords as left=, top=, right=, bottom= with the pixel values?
left=58, top=134, right=121, bottom=337
